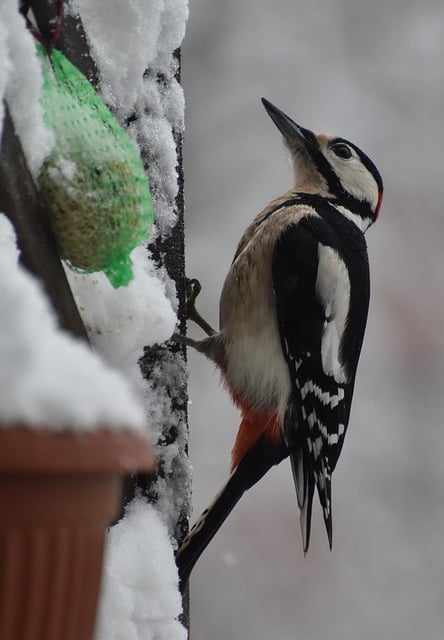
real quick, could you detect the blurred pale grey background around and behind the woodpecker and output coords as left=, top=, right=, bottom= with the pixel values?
left=183, top=0, right=444, bottom=640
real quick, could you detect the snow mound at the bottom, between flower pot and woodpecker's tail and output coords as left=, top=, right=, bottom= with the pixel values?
left=96, top=499, right=187, bottom=640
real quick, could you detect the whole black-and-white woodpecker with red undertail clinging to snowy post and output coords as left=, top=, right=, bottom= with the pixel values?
left=176, top=98, right=383, bottom=583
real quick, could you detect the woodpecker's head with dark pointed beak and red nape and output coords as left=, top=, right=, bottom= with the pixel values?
left=262, top=98, right=383, bottom=231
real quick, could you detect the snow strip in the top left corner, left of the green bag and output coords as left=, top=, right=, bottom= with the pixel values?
left=0, top=0, right=53, bottom=177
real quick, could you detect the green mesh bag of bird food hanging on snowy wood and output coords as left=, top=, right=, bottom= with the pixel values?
left=38, top=45, right=153, bottom=287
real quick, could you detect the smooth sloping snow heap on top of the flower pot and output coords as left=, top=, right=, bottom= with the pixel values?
left=0, top=215, right=145, bottom=431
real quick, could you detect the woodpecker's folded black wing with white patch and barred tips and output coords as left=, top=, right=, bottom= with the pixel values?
left=272, top=215, right=369, bottom=551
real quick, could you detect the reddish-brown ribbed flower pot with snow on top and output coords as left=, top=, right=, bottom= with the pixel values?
left=0, top=427, right=154, bottom=640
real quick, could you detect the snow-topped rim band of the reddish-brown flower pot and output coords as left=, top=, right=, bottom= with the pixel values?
left=0, top=425, right=155, bottom=475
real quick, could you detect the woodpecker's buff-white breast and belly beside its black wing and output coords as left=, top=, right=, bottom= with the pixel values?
left=220, top=198, right=312, bottom=419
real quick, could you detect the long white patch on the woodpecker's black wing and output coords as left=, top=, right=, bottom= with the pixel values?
left=316, top=243, right=350, bottom=384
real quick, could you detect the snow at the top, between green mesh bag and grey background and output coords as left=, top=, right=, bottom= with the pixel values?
left=74, top=0, right=188, bottom=234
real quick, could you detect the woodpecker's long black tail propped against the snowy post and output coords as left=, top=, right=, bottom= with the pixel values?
left=176, top=436, right=289, bottom=587
